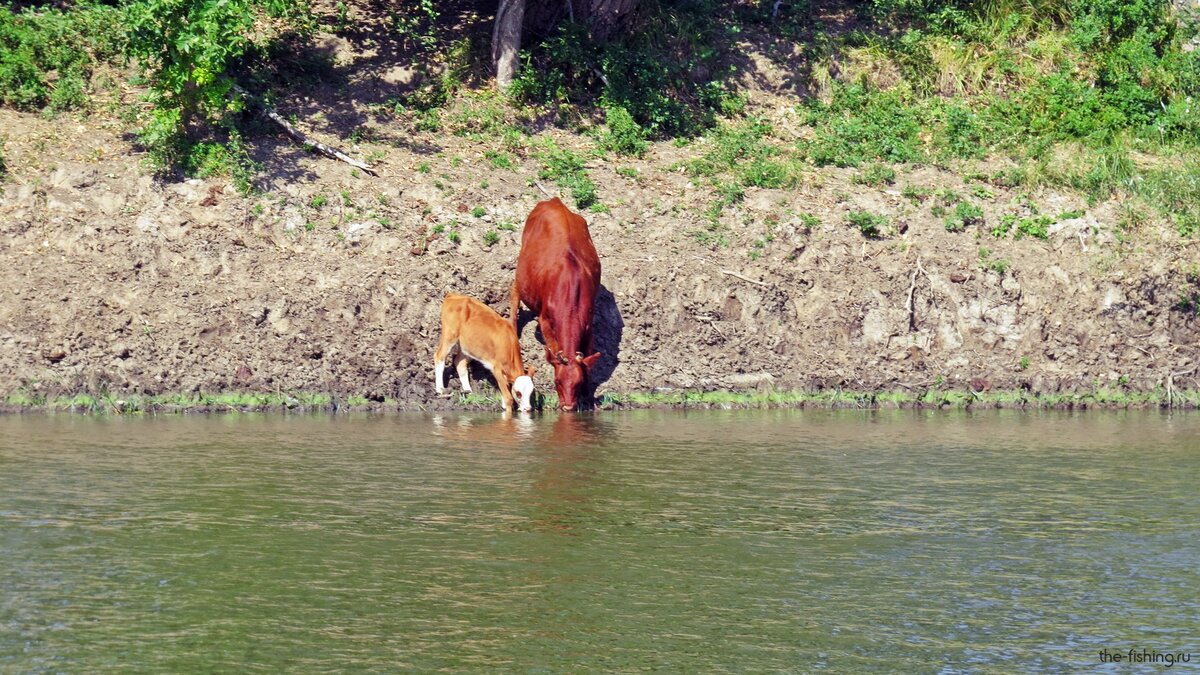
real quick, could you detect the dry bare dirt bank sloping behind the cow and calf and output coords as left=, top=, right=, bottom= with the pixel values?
left=0, top=110, right=1200, bottom=407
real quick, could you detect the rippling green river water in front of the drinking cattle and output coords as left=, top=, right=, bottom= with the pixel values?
left=0, top=411, right=1200, bottom=673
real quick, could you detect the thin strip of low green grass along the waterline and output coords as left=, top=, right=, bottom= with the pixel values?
left=0, top=389, right=1200, bottom=414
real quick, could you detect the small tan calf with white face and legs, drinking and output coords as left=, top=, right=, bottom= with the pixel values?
left=433, top=293, right=534, bottom=412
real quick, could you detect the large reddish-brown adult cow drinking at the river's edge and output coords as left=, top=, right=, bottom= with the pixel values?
left=512, top=198, right=600, bottom=411
